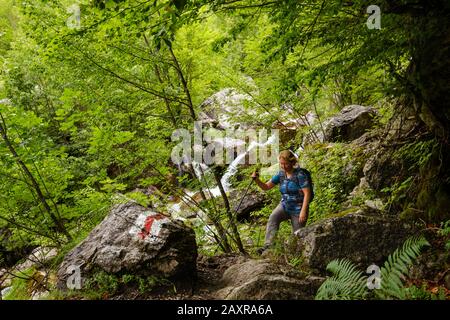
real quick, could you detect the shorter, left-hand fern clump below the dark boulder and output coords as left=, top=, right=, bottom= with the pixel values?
left=316, top=259, right=366, bottom=300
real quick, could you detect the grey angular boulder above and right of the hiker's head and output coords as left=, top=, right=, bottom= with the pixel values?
left=323, top=105, right=376, bottom=142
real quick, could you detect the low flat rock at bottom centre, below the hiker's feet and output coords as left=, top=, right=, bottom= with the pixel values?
left=216, top=259, right=325, bottom=300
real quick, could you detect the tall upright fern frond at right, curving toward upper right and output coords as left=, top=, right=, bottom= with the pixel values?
left=375, top=236, right=430, bottom=299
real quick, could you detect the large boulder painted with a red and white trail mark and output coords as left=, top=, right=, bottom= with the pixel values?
left=58, top=203, right=197, bottom=289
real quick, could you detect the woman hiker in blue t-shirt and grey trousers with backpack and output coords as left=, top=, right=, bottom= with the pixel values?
left=252, top=150, right=311, bottom=254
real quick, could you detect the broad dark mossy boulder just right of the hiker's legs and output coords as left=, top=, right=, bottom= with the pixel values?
left=296, top=209, right=413, bottom=274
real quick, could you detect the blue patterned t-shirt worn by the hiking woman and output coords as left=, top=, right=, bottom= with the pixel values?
left=271, top=168, right=310, bottom=215
